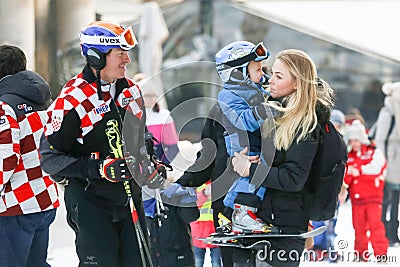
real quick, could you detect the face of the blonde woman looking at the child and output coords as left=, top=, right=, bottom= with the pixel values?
left=269, top=59, right=296, bottom=98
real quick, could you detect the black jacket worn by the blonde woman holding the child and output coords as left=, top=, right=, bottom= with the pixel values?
left=255, top=102, right=330, bottom=233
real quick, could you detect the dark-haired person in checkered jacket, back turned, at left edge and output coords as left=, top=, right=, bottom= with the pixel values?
left=0, top=45, right=60, bottom=267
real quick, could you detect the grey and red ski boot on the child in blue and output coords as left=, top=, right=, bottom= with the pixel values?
left=232, top=204, right=276, bottom=234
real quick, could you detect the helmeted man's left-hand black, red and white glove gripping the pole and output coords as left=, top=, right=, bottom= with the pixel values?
left=99, top=156, right=136, bottom=182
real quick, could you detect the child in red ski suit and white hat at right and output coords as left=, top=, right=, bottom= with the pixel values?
left=344, top=120, right=388, bottom=261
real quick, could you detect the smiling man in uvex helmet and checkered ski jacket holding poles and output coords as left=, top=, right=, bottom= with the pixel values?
left=40, top=21, right=163, bottom=267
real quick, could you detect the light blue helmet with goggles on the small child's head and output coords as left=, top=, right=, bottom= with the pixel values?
left=215, top=41, right=270, bottom=82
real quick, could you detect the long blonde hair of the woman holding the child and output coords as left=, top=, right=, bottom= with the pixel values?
left=264, top=49, right=333, bottom=150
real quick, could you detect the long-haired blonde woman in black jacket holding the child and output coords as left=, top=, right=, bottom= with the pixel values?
left=233, top=49, right=333, bottom=266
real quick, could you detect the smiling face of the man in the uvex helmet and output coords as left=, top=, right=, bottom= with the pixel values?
left=100, top=48, right=131, bottom=83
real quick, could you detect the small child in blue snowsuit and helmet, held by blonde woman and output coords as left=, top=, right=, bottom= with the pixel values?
left=215, top=41, right=280, bottom=233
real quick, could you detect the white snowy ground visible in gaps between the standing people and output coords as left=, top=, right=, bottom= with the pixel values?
left=49, top=141, right=400, bottom=267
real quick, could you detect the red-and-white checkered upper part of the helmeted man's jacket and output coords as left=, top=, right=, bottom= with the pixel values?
left=45, top=73, right=143, bottom=144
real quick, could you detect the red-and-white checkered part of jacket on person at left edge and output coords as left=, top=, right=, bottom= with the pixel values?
left=0, top=102, right=60, bottom=216
